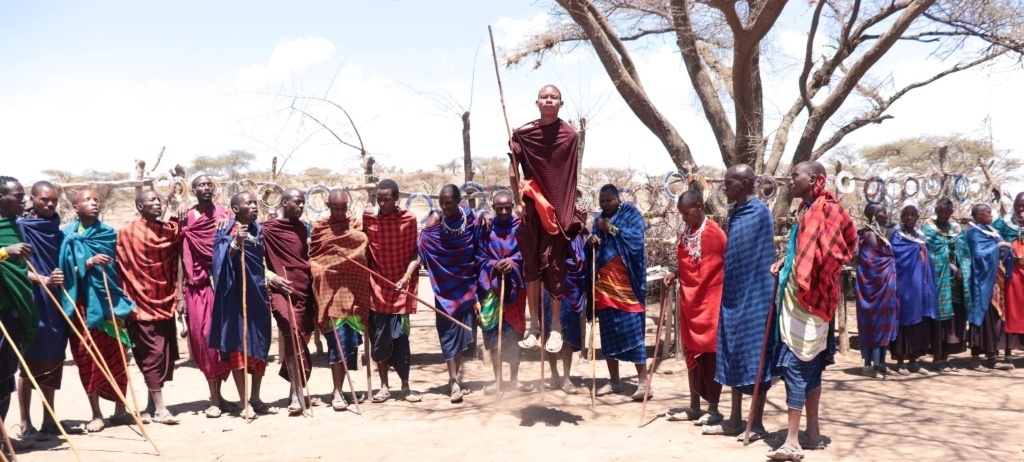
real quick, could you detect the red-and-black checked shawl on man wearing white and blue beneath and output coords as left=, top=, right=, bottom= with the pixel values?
left=794, top=191, right=857, bottom=323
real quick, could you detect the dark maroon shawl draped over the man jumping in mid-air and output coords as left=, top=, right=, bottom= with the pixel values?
left=512, top=119, right=583, bottom=239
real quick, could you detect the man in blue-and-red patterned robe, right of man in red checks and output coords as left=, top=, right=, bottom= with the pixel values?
left=419, top=184, right=478, bottom=403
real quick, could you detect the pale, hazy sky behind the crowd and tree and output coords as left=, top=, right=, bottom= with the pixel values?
left=0, top=0, right=1024, bottom=187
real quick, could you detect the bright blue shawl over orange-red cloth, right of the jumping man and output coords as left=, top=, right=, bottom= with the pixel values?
left=586, top=203, right=647, bottom=307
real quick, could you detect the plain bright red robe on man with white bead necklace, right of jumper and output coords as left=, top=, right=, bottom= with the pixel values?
left=676, top=219, right=726, bottom=362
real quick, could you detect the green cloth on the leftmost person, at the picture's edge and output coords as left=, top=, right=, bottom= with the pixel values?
left=0, top=217, right=39, bottom=345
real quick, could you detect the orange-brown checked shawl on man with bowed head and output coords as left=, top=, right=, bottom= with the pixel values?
left=309, top=217, right=370, bottom=332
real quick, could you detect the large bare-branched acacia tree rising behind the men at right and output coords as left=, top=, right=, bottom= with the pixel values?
left=505, top=0, right=1024, bottom=174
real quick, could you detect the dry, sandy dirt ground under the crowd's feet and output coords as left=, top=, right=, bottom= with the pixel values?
left=7, top=280, right=1024, bottom=462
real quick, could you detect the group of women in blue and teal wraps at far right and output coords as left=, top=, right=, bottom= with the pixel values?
left=857, top=194, right=1024, bottom=378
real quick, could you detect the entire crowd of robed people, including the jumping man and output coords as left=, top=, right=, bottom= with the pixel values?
left=0, top=86, right=1007, bottom=460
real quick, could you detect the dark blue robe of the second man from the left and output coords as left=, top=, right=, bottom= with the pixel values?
left=17, top=215, right=68, bottom=361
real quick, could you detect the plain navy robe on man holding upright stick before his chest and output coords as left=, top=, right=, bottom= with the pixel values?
left=209, top=219, right=270, bottom=363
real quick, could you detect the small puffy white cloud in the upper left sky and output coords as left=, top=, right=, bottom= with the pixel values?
left=238, top=37, right=335, bottom=90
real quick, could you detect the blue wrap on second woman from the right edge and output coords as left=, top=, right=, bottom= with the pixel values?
left=967, top=224, right=1001, bottom=327
